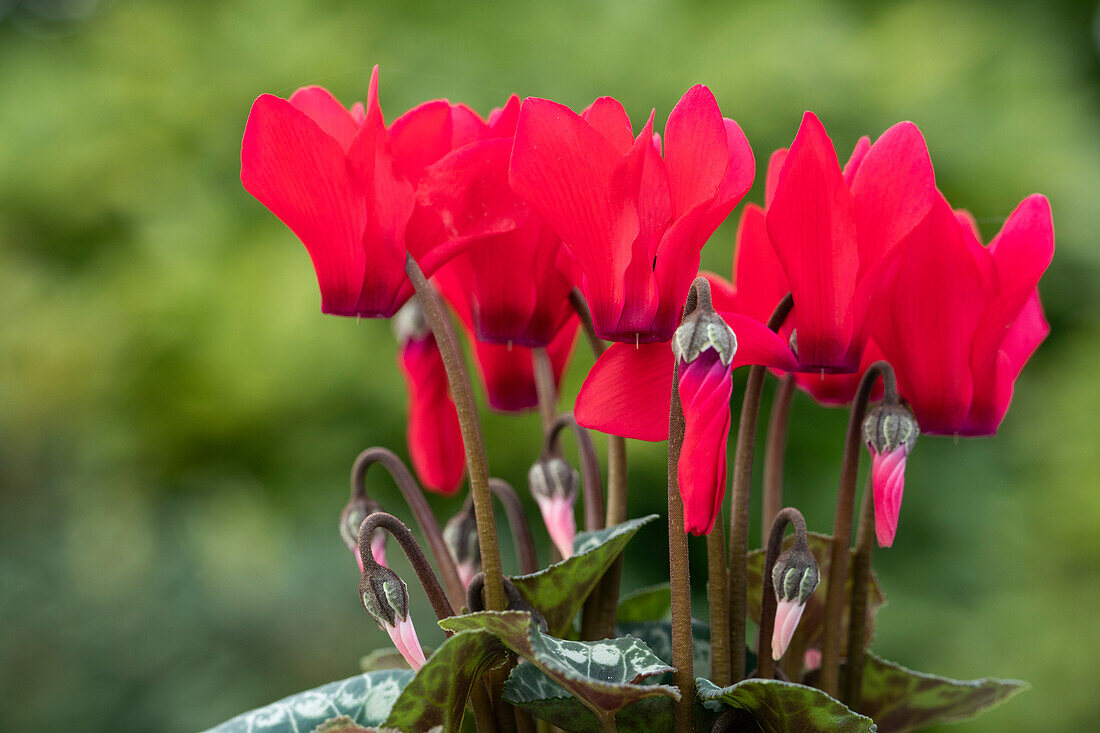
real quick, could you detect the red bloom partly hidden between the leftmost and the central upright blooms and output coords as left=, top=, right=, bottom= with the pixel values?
left=418, top=96, right=573, bottom=347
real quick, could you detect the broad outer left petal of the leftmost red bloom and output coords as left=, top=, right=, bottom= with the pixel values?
left=241, top=95, right=387, bottom=316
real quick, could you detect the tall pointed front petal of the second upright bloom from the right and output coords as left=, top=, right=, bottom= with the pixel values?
left=767, top=112, right=866, bottom=371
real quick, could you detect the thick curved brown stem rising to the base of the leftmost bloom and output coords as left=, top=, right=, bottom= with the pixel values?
left=405, top=255, right=507, bottom=611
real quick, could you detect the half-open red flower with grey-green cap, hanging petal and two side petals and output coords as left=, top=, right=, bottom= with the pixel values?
left=574, top=277, right=798, bottom=535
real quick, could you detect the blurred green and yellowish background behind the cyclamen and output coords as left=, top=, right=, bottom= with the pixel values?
left=0, top=0, right=1100, bottom=733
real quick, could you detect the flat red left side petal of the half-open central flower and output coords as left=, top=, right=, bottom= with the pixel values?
left=574, top=342, right=673, bottom=441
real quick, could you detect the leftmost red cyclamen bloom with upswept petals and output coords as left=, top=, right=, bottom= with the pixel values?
left=241, top=67, right=484, bottom=318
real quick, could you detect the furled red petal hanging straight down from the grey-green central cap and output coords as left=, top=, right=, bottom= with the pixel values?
left=677, top=351, right=734, bottom=535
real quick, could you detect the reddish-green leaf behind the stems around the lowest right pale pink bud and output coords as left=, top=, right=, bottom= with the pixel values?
left=748, top=532, right=887, bottom=649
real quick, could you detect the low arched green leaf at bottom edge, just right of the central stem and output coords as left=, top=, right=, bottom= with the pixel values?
left=695, top=677, right=877, bottom=733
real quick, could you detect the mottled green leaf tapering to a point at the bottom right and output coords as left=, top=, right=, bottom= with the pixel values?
left=859, top=654, right=1031, bottom=733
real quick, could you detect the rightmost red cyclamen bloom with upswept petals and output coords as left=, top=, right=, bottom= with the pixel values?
left=875, top=194, right=1054, bottom=436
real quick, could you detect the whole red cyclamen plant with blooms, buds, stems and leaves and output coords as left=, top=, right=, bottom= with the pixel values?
left=216, top=68, right=1054, bottom=732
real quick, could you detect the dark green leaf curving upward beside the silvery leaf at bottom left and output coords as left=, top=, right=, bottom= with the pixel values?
left=385, top=630, right=505, bottom=733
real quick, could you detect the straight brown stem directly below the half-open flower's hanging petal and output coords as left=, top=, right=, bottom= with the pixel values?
left=669, top=363, right=695, bottom=733
